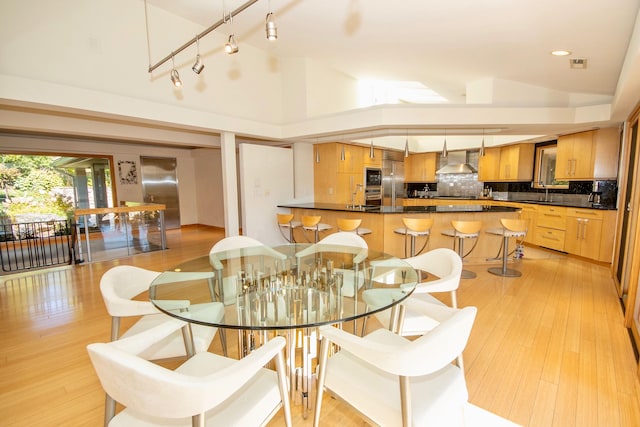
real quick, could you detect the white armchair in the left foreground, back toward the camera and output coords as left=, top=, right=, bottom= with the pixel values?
left=87, top=319, right=291, bottom=427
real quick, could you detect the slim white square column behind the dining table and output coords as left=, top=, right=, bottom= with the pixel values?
left=220, top=132, right=240, bottom=236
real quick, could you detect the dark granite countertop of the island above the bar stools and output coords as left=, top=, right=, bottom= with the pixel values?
left=278, top=203, right=518, bottom=214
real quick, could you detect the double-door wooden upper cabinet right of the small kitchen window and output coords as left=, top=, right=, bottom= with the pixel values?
left=556, top=128, right=620, bottom=181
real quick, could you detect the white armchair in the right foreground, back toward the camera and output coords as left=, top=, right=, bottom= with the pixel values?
left=314, top=307, right=477, bottom=427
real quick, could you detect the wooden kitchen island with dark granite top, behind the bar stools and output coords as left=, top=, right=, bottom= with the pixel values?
left=278, top=203, right=520, bottom=262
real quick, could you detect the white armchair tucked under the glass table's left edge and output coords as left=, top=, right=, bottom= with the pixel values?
left=100, top=265, right=227, bottom=419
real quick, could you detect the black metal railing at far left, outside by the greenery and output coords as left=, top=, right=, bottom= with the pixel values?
left=0, top=220, right=76, bottom=272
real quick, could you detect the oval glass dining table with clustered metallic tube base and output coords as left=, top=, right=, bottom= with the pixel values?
left=149, top=244, right=418, bottom=417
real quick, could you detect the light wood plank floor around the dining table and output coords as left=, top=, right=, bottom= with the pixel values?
left=0, top=227, right=640, bottom=426
